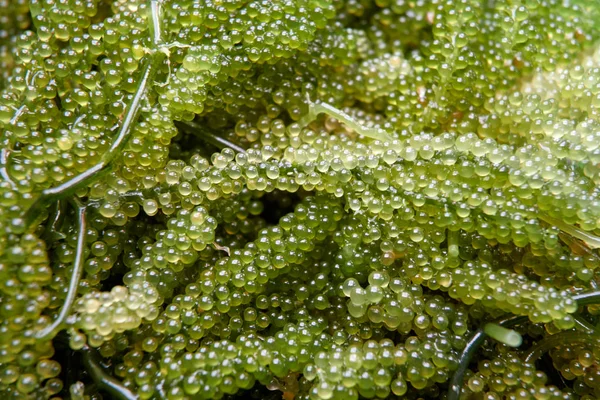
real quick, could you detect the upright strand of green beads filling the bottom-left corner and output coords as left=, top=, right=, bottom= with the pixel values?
left=0, top=227, right=62, bottom=399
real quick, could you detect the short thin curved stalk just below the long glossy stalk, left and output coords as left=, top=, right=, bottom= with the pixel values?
left=35, top=200, right=87, bottom=341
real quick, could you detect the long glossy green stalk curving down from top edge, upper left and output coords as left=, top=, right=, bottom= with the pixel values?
left=25, top=0, right=165, bottom=227
